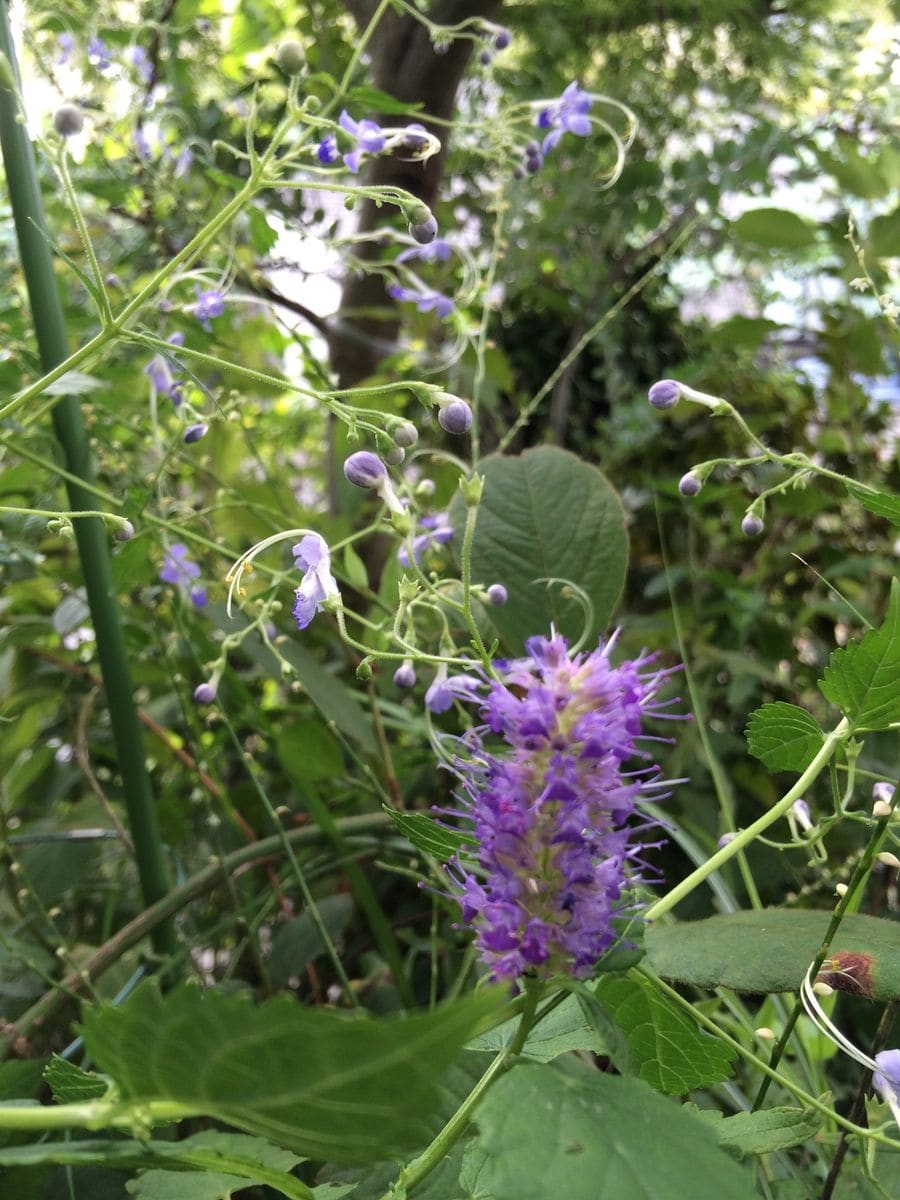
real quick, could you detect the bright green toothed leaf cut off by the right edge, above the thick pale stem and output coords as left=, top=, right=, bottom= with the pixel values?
left=818, top=578, right=900, bottom=730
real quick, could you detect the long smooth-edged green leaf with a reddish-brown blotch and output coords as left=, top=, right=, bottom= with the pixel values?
left=646, top=908, right=900, bottom=1001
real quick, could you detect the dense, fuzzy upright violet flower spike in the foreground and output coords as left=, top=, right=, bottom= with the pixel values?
left=444, top=631, right=677, bottom=979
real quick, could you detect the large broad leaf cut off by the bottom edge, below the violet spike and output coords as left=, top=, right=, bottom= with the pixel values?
left=472, top=1063, right=755, bottom=1200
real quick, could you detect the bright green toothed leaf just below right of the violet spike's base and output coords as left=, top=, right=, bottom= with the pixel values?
left=596, top=976, right=734, bottom=1096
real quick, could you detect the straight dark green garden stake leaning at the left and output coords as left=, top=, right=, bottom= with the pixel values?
left=0, top=7, right=178, bottom=956
